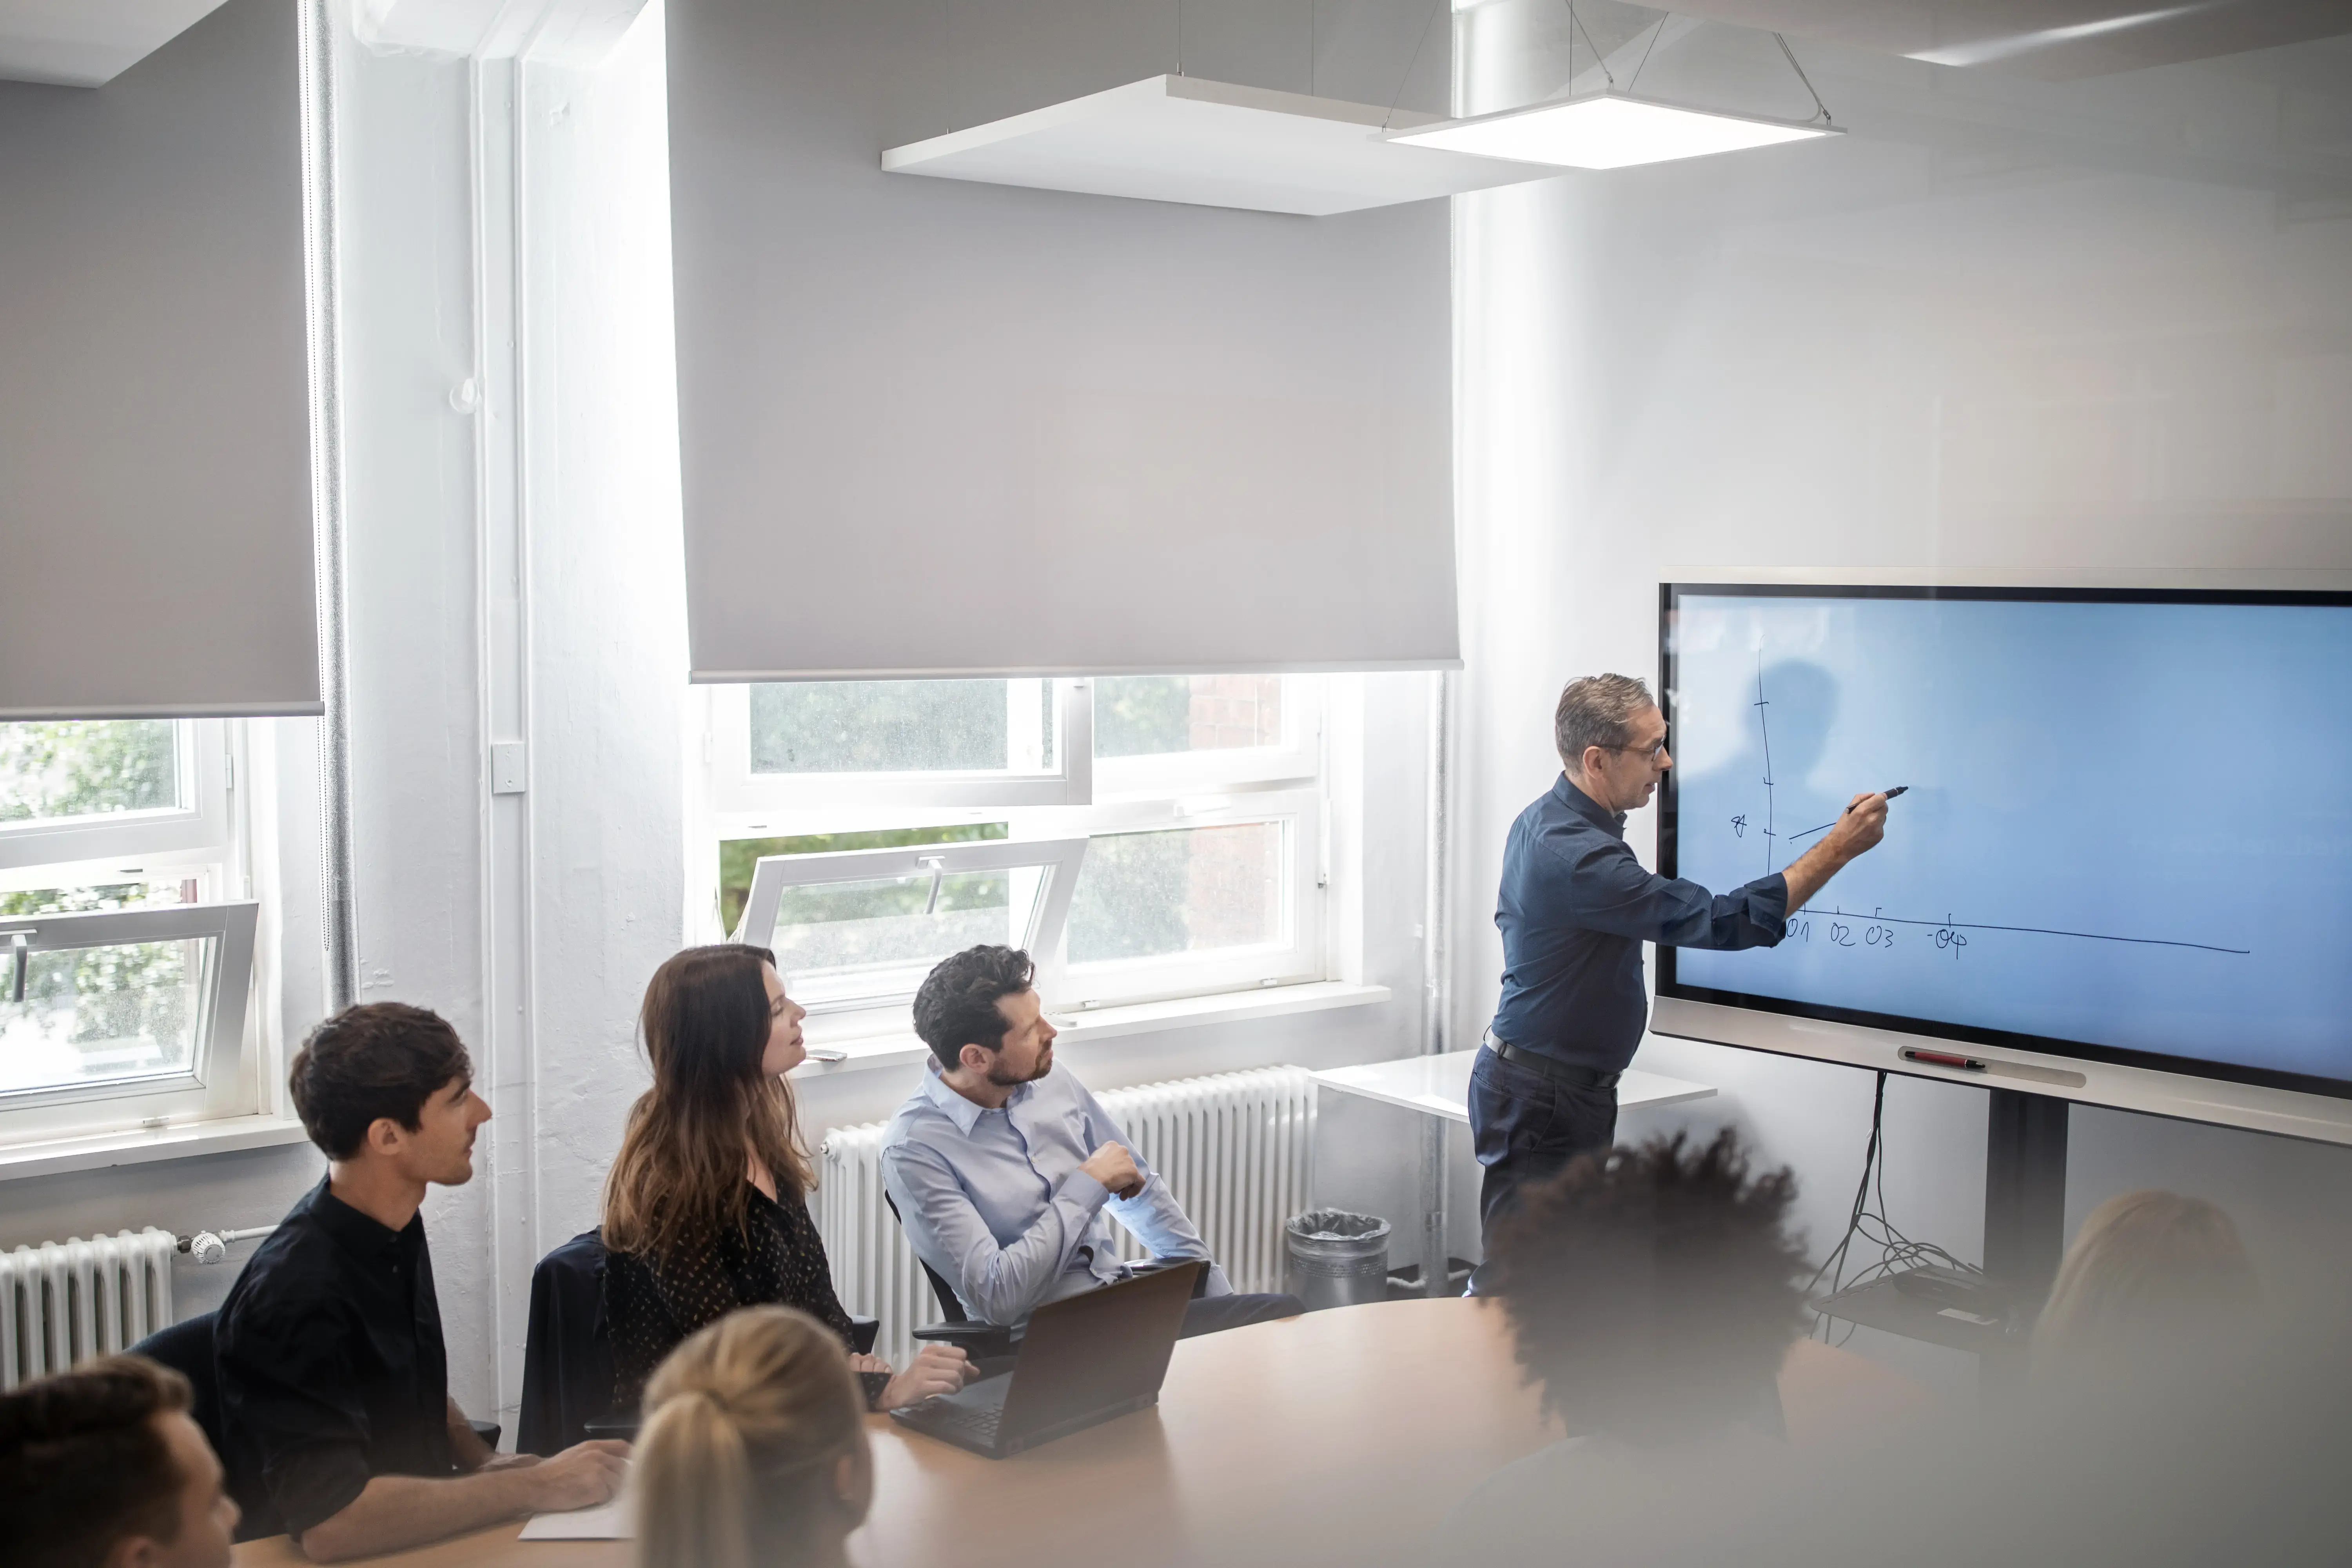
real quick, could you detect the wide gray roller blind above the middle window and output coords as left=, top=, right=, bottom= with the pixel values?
left=668, top=0, right=1458, bottom=679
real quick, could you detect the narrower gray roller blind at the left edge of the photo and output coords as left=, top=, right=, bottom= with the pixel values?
left=0, top=0, right=320, bottom=717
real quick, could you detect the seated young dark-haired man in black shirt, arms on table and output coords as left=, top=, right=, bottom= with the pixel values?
left=214, top=1002, right=628, bottom=1561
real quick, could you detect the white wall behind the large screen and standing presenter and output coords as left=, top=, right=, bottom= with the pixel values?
left=1454, top=0, right=2352, bottom=1380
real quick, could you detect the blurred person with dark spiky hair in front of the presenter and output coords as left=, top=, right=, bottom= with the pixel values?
left=1439, top=1129, right=1811, bottom=1561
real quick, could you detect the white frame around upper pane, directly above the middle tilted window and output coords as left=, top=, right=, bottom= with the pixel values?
left=708, top=679, right=1094, bottom=837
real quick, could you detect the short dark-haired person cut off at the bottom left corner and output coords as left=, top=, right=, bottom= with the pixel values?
left=0, top=1356, right=238, bottom=1568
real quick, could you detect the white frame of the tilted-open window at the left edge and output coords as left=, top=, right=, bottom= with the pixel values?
left=0, top=900, right=261, bottom=1143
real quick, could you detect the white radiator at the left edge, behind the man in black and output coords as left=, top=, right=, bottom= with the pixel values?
left=0, top=1227, right=179, bottom=1389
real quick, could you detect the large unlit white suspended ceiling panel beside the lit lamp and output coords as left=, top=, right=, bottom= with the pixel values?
left=882, top=75, right=1555, bottom=219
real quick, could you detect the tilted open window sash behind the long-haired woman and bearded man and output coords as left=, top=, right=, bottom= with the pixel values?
left=736, top=839, right=1087, bottom=1013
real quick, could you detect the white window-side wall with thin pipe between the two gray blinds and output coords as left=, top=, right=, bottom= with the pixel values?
left=0, top=5, right=1428, bottom=1415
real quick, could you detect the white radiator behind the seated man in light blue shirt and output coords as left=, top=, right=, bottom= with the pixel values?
left=816, top=1067, right=1315, bottom=1366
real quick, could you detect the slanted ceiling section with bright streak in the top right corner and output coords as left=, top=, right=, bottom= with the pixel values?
left=1672, top=0, right=2352, bottom=80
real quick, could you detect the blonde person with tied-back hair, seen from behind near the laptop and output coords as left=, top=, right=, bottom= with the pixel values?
left=633, top=1307, right=875, bottom=1568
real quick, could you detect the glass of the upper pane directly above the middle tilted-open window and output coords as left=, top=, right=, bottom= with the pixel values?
left=750, top=679, right=1061, bottom=773
